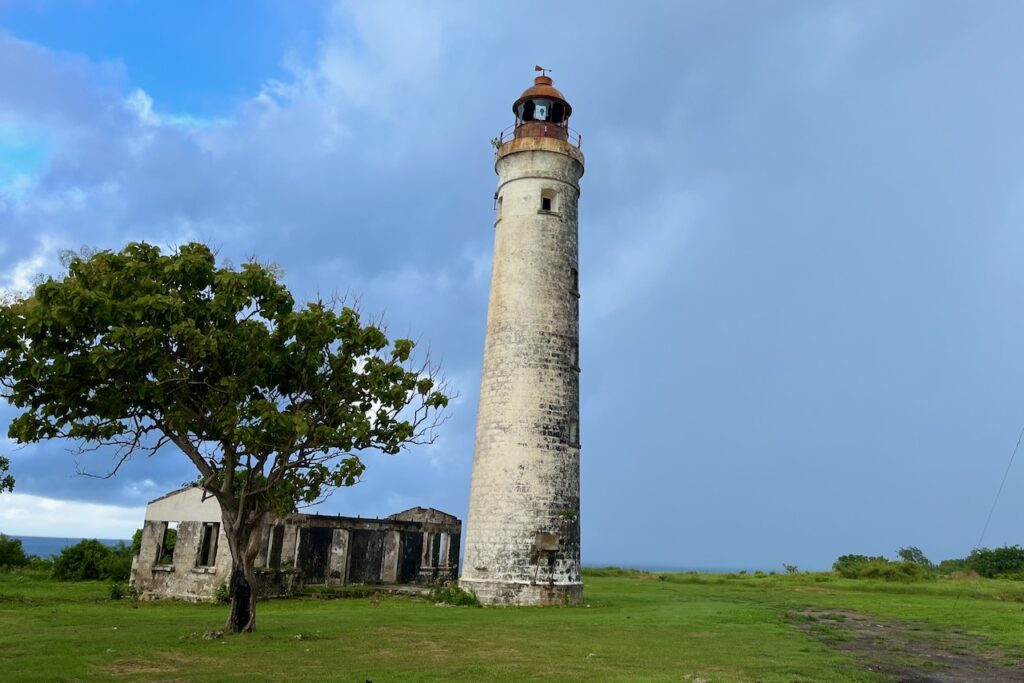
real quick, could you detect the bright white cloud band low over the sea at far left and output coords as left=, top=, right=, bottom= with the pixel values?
left=0, top=494, right=145, bottom=539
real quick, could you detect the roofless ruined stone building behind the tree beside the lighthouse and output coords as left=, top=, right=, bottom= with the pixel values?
left=132, top=486, right=462, bottom=600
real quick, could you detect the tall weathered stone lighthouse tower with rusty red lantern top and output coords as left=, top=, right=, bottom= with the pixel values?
left=461, top=69, right=584, bottom=605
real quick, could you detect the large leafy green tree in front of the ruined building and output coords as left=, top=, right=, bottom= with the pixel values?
left=0, top=243, right=449, bottom=632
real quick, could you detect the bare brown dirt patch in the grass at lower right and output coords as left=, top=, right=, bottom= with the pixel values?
left=787, top=609, right=1024, bottom=683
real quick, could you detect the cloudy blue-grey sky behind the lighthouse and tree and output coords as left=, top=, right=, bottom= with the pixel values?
left=0, top=0, right=1024, bottom=570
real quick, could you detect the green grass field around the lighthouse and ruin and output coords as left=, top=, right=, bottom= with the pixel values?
left=0, top=569, right=1024, bottom=683
